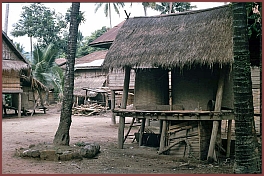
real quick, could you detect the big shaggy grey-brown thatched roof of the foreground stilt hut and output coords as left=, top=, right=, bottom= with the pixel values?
left=104, top=5, right=233, bottom=68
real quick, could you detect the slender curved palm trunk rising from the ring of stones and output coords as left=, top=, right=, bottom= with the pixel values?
left=53, top=3, right=80, bottom=145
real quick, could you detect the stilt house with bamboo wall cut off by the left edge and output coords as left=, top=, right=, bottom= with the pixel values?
left=2, top=32, right=47, bottom=117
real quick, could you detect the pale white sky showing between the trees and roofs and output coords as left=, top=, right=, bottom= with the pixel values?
left=2, top=2, right=227, bottom=51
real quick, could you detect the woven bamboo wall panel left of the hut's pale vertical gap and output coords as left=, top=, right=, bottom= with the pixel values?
left=134, top=68, right=169, bottom=108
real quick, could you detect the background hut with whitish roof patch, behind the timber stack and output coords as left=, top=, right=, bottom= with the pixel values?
left=73, top=50, right=107, bottom=106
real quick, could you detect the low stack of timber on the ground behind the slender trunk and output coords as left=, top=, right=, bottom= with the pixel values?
left=72, top=103, right=106, bottom=116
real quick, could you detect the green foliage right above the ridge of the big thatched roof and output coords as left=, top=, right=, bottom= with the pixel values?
left=154, top=2, right=196, bottom=14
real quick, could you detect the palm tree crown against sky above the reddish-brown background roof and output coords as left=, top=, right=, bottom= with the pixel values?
left=95, top=2, right=125, bottom=28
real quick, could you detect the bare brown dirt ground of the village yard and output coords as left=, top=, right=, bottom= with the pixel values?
left=2, top=105, right=233, bottom=174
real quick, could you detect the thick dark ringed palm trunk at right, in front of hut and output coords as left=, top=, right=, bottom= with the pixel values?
left=233, top=3, right=257, bottom=174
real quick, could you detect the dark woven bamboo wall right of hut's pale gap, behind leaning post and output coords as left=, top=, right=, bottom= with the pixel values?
left=171, top=67, right=233, bottom=110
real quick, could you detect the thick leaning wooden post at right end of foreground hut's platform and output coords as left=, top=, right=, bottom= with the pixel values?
left=207, top=68, right=225, bottom=162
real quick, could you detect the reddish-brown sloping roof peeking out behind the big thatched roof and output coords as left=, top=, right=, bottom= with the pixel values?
left=89, top=21, right=125, bottom=49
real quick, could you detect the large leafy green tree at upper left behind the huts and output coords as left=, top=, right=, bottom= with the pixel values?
left=11, top=3, right=67, bottom=59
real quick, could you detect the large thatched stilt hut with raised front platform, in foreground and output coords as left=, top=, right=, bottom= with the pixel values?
left=104, top=5, right=260, bottom=160
